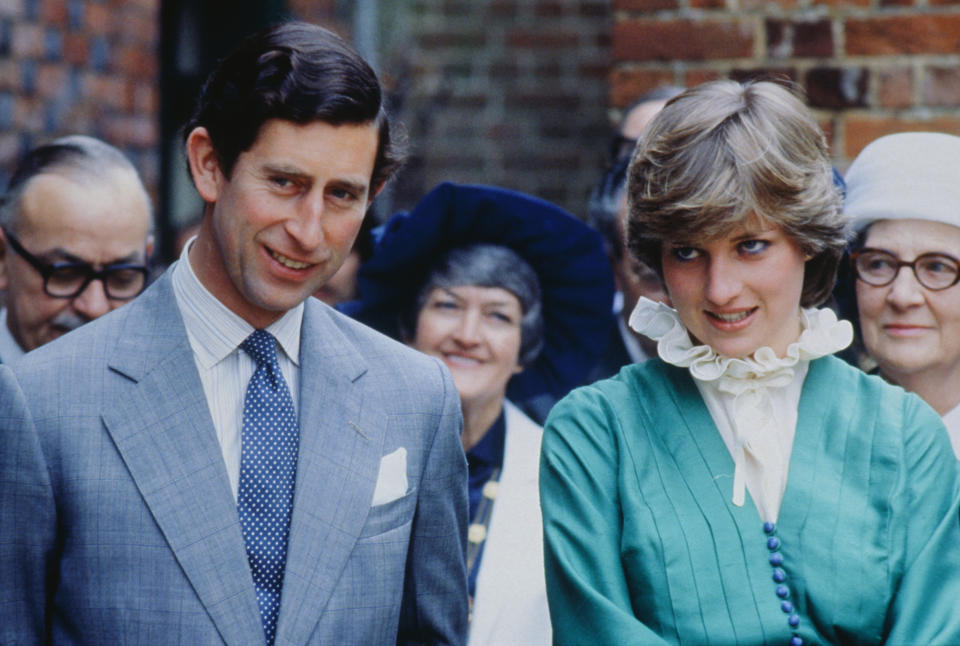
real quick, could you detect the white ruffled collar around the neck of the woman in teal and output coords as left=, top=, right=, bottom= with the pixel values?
left=630, top=297, right=853, bottom=385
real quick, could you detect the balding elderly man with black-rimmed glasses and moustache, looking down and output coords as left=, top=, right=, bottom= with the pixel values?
left=0, top=135, right=153, bottom=362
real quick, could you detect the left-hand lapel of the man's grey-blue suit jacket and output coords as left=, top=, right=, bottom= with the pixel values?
left=103, top=271, right=263, bottom=645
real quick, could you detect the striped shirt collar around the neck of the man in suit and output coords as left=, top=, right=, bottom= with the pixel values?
left=171, top=238, right=304, bottom=368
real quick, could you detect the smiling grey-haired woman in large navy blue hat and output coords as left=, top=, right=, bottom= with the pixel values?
left=344, top=184, right=613, bottom=646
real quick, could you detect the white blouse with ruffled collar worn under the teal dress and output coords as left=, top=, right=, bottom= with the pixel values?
left=630, top=298, right=853, bottom=522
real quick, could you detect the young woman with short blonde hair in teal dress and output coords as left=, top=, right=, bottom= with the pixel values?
left=540, top=81, right=960, bottom=646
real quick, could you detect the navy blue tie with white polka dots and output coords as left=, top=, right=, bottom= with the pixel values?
left=237, top=330, right=300, bottom=646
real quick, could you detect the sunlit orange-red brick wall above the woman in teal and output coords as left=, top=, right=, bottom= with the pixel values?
left=610, top=0, right=960, bottom=168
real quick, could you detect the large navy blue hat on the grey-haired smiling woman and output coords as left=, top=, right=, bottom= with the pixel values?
left=339, top=183, right=614, bottom=402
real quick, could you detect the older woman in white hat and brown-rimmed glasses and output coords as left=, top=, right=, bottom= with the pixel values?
left=845, top=132, right=960, bottom=457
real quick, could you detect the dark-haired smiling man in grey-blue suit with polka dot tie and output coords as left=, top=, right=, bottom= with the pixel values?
left=0, top=23, right=467, bottom=646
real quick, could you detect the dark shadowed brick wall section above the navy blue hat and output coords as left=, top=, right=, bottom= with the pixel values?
left=381, top=0, right=611, bottom=215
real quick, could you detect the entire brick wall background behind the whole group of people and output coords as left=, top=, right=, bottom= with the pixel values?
left=11, top=0, right=940, bottom=218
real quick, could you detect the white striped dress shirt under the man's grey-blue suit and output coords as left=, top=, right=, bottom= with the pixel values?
left=171, top=239, right=303, bottom=499
